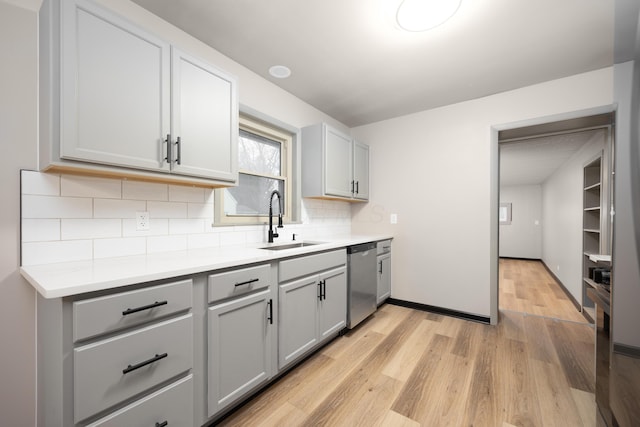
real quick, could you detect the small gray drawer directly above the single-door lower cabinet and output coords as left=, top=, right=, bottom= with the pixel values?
left=209, top=264, right=270, bottom=302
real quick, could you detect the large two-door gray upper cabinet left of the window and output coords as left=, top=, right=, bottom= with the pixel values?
left=40, top=0, right=238, bottom=185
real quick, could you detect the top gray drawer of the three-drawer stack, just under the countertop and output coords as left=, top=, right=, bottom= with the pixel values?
left=73, top=279, right=193, bottom=342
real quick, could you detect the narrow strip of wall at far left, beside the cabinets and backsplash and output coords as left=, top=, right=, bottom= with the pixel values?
left=0, top=1, right=37, bottom=427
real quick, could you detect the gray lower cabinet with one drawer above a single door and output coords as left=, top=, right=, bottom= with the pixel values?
left=208, top=265, right=276, bottom=417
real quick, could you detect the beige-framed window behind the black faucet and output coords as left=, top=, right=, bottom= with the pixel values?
left=215, top=116, right=292, bottom=225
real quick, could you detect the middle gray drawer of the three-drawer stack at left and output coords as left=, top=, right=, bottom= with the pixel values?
left=73, top=314, right=193, bottom=422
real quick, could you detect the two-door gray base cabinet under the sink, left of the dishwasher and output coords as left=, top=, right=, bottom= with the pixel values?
left=278, top=250, right=347, bottom=369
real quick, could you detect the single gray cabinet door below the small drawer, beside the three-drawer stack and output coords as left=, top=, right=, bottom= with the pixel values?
left=208, top=289, right=273, bottom=416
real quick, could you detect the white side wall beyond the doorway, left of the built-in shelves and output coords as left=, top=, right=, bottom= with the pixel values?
left=542, top=130, right=606, bottom=304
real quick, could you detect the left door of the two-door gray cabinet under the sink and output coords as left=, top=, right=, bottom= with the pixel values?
left=278, top=275, right=320, bottom=368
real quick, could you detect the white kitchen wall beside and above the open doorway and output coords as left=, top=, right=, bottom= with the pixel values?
left=351, top=68, right=613, bottom=317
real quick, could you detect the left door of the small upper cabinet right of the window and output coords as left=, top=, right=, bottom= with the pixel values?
left=324, top=126, right=353, bottom=198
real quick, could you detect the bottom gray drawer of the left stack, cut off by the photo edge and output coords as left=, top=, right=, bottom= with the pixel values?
left=87, top=375, right=193, bottom=427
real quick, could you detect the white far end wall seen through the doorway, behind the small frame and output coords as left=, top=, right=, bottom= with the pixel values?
left=499, top=185, right=542, bottom=259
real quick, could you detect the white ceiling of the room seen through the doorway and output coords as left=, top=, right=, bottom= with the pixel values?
left=500, top=129, right=603, bottom=186
